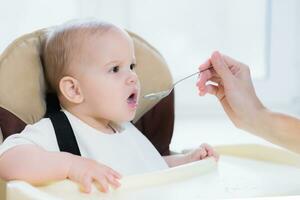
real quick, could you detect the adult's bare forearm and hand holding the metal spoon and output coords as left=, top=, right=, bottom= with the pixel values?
left=197, top=52, right=300, bottom=154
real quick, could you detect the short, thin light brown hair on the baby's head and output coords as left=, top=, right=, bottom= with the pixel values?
left=42, top=20, right=116, bottom=93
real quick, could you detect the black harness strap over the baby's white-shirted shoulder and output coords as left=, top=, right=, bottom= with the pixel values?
left=49, top=111, right=81, bottom=156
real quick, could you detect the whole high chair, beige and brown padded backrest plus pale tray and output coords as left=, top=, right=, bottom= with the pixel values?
left=0, top=26, right=300, bottom=200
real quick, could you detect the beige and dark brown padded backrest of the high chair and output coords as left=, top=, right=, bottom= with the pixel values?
left=0, top=29, right=174, bottom=155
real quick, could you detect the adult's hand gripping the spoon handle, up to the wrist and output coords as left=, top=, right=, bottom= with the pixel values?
left=197, top=52, right=264, bottom=131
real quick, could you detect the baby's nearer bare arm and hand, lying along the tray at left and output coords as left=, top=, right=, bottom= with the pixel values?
left=0, top=144, right=121, bottom=192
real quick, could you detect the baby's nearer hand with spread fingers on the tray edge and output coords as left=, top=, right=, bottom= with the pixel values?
left=68, top=155, right=121, bottom=193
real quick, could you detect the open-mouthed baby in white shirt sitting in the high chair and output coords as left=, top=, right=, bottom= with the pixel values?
left=0, top=21, right=218, bottom=192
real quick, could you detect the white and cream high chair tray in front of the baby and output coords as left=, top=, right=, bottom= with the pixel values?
left=1, top=144, right=300, bottom=200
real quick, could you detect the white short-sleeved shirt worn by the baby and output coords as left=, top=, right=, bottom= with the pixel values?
left=0, top=110, right=168, bottom=175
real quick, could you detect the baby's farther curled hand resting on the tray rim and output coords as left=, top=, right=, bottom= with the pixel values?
left=186, top=143, right=219, bottom=162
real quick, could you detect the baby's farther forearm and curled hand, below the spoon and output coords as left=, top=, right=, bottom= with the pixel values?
left=164, top=144, right=219, bottom=167
